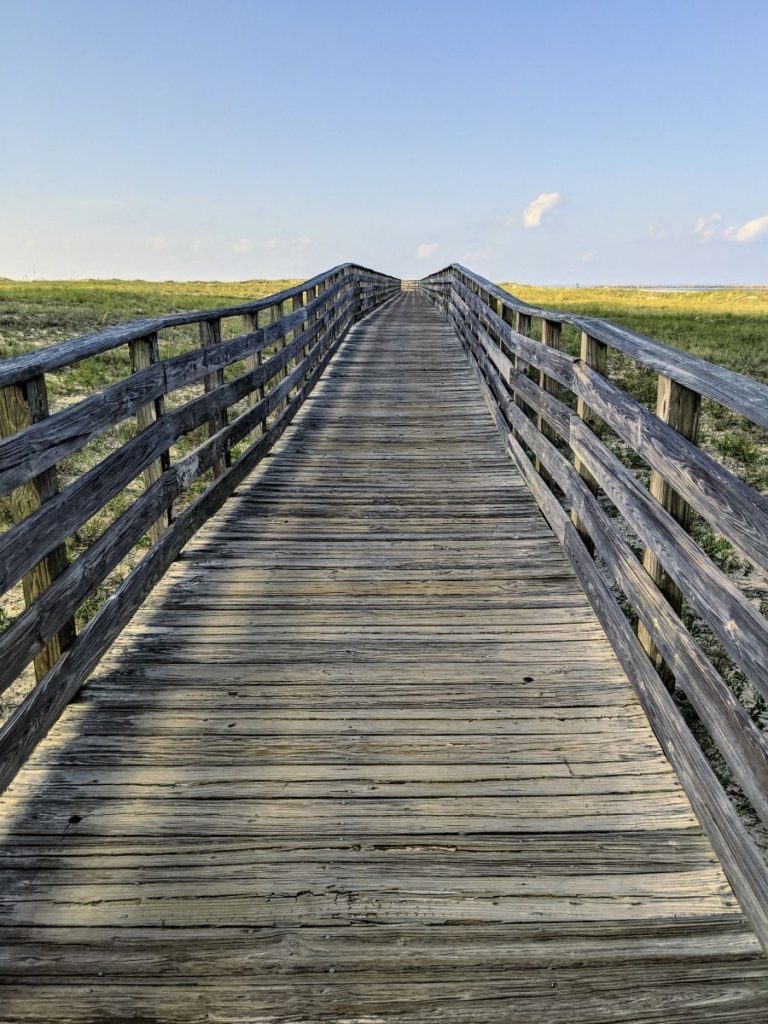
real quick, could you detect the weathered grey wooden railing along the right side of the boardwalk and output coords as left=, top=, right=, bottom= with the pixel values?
left=420, top=265, right=768, bottom=946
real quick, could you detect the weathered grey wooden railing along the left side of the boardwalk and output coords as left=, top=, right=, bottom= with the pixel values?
left=0, top=264, right=399, bottom=790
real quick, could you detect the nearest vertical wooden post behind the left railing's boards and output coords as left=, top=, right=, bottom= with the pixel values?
left=0, top=374, right=75, bottom=682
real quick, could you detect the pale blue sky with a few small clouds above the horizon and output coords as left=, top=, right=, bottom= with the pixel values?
left=0, top=0, right=768, bottom=284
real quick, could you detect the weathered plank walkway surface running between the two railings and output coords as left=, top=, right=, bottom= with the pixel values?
left=0, top=294, right=768, bottom=1024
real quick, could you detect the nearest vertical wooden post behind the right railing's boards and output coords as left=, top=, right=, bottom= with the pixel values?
left=637, top=374, right=701, bottom=690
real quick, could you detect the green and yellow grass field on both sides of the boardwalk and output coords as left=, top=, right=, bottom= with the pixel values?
left=0, top=280, right=768, bottom=848
